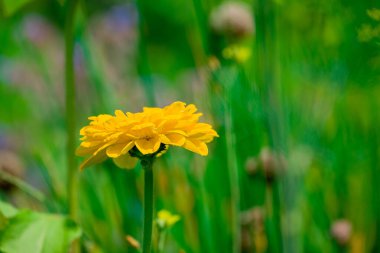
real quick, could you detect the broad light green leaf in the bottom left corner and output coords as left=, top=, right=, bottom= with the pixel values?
left=0, top=202, right=81, bottom=253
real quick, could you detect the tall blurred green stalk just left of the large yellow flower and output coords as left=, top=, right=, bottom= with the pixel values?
left=65, top=0, right=78, bottom=219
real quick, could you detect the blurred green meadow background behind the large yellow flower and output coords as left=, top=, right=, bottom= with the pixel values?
left=0, top=0, right=380, bottom=253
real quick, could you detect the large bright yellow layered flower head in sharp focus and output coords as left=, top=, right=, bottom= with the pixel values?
left=76, top=102, right=218, bottom=169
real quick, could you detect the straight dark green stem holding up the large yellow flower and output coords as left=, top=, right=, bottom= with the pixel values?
left=141, top=158, right=153, bottom=253
